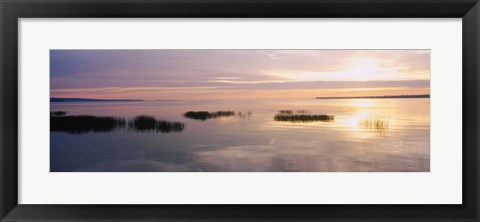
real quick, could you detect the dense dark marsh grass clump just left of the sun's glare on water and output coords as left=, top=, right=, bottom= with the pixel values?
left=274, top=110, right=335, bottom=122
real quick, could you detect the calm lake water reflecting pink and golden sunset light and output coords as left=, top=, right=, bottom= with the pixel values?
left=50, top=98, right=430, bottom=172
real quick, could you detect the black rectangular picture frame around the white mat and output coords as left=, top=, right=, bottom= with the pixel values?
left=0, top=0, right=480, bottom=221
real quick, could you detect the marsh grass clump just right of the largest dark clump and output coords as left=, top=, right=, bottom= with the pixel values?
left=128, top=116, right=185, bottom=133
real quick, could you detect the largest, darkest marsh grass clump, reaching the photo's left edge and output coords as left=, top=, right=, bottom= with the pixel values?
left=50, top=115, right=126, bottom=134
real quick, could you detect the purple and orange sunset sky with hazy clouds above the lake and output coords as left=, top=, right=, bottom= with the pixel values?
left=50, top=49, right=430, bottom=100
